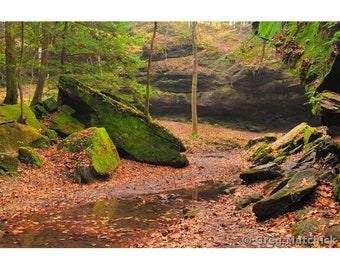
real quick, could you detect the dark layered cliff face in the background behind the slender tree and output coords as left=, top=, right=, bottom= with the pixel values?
left=140, top=64, right=316, bottom=129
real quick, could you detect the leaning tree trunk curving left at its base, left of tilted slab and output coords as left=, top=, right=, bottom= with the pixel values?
left=31, top=22, right=50, bottom=106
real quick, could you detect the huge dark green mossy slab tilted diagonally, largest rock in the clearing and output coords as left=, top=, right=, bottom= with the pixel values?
left=58, top=76, right=188, bottom=167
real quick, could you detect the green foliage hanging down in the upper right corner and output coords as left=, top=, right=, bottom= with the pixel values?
left=259, top=22, right=340, bottom=113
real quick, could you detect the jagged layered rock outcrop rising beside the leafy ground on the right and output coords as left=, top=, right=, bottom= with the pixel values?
left=240, top=123, right=340, bottom=220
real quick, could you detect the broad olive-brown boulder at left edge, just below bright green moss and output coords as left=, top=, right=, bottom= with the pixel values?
left=0, top=122, right=49, bottom=152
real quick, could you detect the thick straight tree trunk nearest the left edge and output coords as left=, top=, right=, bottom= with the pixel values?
left=4, top=22, right=18, bottom=104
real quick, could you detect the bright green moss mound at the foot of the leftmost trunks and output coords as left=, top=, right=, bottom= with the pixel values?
left=0, top=104, right=45, bottom=129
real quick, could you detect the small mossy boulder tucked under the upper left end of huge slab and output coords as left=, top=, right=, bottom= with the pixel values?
left=49, top=105, right=85, bottom=138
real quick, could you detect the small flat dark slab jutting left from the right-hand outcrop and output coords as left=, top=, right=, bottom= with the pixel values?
left=240, top=162, right=282, bottom=183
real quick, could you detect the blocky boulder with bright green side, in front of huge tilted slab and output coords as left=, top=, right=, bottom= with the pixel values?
left=60, top=127, right=120, bottom=183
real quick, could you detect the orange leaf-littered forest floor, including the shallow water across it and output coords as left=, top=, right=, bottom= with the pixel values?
left=0, top=120, right=340, bottom=248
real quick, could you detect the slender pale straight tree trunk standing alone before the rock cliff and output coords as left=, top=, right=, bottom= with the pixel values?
left=191, top=22, right=198, bottom=136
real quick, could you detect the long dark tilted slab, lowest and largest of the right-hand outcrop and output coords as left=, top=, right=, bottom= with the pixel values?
left=253, top=169, right=318, bottom=220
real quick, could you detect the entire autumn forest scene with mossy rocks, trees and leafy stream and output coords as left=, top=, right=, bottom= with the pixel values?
left=0, top=21, right=340, bottom=254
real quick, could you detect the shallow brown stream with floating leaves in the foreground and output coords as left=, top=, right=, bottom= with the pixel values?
left=0, top=181, right=229, bottom=248
